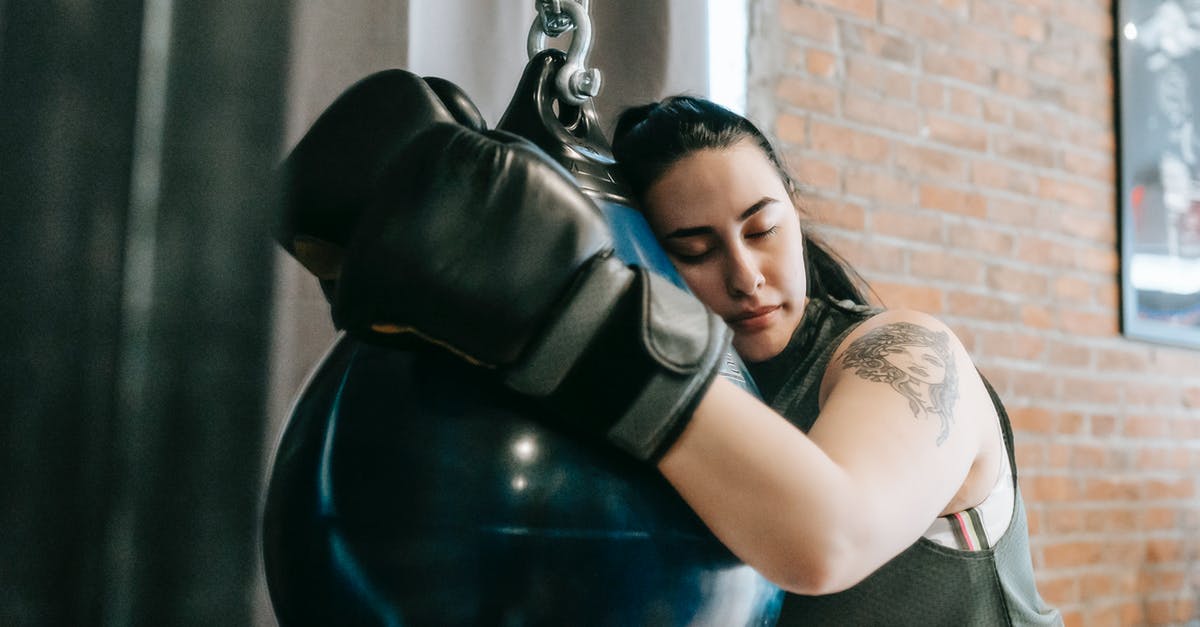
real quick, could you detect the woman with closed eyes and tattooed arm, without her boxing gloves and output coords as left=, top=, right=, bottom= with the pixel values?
left=613, top=97, right=1060, bottom=625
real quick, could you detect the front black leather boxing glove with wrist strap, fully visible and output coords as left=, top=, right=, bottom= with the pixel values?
left=334, top=124, right=731, bottom=460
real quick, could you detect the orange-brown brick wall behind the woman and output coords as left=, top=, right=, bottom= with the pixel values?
left=750, top=0, right=1200, bottom=626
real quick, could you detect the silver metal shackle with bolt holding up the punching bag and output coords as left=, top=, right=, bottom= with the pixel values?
left=526, top=0, right=600, bottom=107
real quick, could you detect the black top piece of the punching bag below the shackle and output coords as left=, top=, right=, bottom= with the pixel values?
left=497, top=48, right=632, bottom=205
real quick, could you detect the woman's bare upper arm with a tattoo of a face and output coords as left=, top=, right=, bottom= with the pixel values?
left=808, top=310, right=995, bottom=572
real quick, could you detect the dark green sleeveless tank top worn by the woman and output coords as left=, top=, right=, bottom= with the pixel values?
left=748, top=298, right=1062, bottom=627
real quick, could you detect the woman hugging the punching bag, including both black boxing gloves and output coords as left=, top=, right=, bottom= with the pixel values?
left=309, top=74, right=1060, bottom=625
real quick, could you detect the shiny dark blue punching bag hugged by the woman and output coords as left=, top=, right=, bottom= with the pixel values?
left=263, top=56, right=782, bottom=627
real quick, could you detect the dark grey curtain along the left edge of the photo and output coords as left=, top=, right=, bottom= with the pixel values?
left=0, top=0, right=289, bottom=626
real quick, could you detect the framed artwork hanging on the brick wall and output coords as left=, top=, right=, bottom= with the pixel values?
left=1116, top=0, right=1200, bottom=348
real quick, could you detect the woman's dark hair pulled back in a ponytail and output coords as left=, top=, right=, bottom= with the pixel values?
left=612, top=96, right=870, bottom=305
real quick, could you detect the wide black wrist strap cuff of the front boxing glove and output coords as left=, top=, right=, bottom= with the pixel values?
left=505, top=257, right=731, bottom=461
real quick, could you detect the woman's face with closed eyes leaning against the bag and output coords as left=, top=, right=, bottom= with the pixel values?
left=644, top=141, right=806, bottom=362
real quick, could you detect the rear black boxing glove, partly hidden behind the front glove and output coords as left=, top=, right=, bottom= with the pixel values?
left=275, top=70, right=486, bottom=290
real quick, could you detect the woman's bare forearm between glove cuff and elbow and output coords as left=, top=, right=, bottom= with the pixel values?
left=659, top=372, right=874, bottom=595
